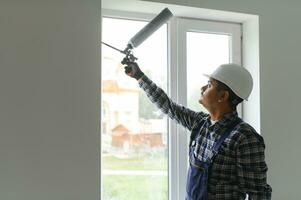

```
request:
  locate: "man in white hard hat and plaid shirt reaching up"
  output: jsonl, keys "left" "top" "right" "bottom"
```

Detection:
{"left": 122, "top": 59, "right": 272, "bottom": 200}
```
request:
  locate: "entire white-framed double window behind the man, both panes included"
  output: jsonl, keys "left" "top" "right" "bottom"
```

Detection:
{"left": 101, "top": 11, "right": 241, "bottom": 200}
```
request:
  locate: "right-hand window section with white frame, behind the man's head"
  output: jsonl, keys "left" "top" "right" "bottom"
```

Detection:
{"left": 170, "top": 18, "right": 241, "bottom": 199}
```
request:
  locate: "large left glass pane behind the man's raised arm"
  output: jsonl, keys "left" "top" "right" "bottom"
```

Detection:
{"left": 101, "top": 18, "right": 168, "bottom": 200}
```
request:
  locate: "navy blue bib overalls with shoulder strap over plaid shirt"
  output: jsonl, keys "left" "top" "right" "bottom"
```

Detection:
{"left": 186, "top": 119, "right": 240, "bottom": 200}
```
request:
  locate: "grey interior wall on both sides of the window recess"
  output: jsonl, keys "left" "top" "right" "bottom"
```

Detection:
{"left": 0, "top": 0, "right": 301, "bottom": 200}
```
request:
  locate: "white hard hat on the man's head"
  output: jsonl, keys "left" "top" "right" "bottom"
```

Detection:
{"left": 204, "top": 63, "right": 253, "bottom": 100}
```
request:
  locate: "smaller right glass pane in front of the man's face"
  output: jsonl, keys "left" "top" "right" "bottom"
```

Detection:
{"left": 186, "top": 32, "right": 230, "bottom": 112}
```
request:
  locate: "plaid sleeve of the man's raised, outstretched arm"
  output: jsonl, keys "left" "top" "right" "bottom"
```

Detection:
{"left": 138, "top": 75, "right": 205, "bottom": 130}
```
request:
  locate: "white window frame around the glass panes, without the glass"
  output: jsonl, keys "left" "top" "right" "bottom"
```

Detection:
{"left": 102, "top": 9, "right": 242, "bottom": 200}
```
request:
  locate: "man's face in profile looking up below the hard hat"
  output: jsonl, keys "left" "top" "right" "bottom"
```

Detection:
{"left": 199, "top": 78, "right": 219, "bottom": 109}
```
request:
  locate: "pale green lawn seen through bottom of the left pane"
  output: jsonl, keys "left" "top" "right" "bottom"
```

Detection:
{"left": 102, "top": 154, "right": 168, "bottom": 200}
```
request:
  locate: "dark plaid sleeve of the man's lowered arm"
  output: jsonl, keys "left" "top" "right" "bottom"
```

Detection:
{"left": 237, "top": 133, "right": 272, "bottom": 200}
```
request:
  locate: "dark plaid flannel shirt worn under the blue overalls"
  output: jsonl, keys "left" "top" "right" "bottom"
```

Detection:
{"left": 139, "top": 76, "right": 272, "bottom": 200}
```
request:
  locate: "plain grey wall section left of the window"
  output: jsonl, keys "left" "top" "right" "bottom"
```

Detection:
{"left": 0, "top": 0, "right": 101, "bottom": 200}
